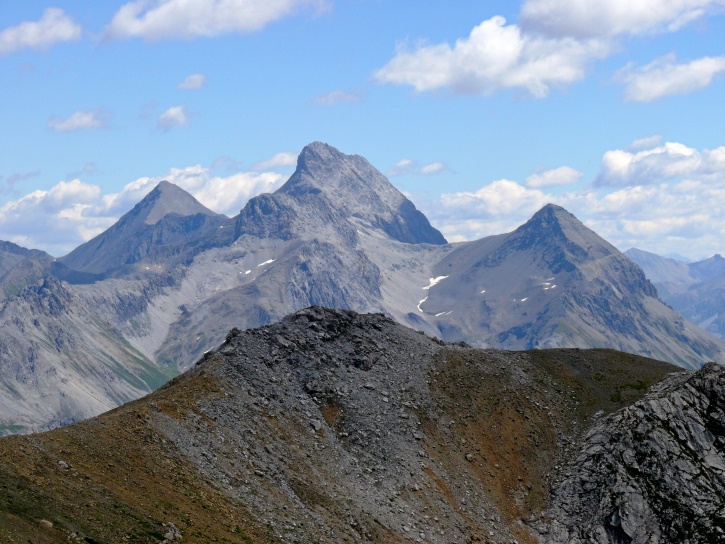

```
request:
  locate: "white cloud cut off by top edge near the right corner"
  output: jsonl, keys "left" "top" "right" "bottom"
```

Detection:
{"left": 521, "top": 0, "right": 725, "bottom": 38}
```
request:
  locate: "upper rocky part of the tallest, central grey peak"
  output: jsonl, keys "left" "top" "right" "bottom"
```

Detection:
{"left": 235, "top": 142, "right": 446, "bottom": 244}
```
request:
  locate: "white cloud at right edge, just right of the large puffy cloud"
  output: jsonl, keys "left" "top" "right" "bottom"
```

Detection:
{"left": 615, "top": 55, "right": 725, "bottom": 102}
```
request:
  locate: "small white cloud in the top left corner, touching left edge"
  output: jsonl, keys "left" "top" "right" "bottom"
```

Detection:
{"left": 0, "top": 8, "right": 82, "bottom": 55}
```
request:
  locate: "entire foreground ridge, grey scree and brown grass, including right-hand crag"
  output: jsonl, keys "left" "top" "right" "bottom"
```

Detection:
{"left": 0, "top": 307, "right": 725, "bottom": 544}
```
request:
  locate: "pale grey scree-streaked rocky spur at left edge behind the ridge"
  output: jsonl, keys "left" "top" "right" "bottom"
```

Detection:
{"left": 0, "top": 276, "right": 173, "bottom": 434}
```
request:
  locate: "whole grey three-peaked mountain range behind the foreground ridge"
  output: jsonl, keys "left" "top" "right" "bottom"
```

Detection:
{"left": 0, "top": 142, "right": 725, "bottom": 432}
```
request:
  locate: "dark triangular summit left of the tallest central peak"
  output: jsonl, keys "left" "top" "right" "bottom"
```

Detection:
{"left": 58, "top": 181, "right": 229, "bottom": 277}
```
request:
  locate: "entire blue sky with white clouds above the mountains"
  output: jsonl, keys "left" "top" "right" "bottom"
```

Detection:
{"left": 0, "top": 0, "right": 725, "bottom": 258}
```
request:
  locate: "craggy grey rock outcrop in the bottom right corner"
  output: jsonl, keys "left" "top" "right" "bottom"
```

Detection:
{"left": 542, "top": 363, "right": 725, "bottom": 544}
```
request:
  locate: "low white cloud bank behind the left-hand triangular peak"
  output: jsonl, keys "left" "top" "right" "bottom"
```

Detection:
{"left": 0, "top": 165, "right": 286, "bottom": 256}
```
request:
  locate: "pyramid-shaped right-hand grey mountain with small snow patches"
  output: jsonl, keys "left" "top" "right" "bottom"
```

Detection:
{"left": 421, "top": 205, "right": 723, "bottom": 368}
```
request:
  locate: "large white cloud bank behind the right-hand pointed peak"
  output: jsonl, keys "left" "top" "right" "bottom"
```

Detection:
{"left": 421, "top": 139, "right": 725, "bottom": 259}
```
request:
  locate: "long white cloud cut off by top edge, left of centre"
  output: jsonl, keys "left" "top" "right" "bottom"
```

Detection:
{"left": 107, "top": 0, "right": 327, "bottom": 40}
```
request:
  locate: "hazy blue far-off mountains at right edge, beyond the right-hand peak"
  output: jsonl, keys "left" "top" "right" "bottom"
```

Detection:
{"left": 625, "top": 248, "right": 725, "bottom": 339}
